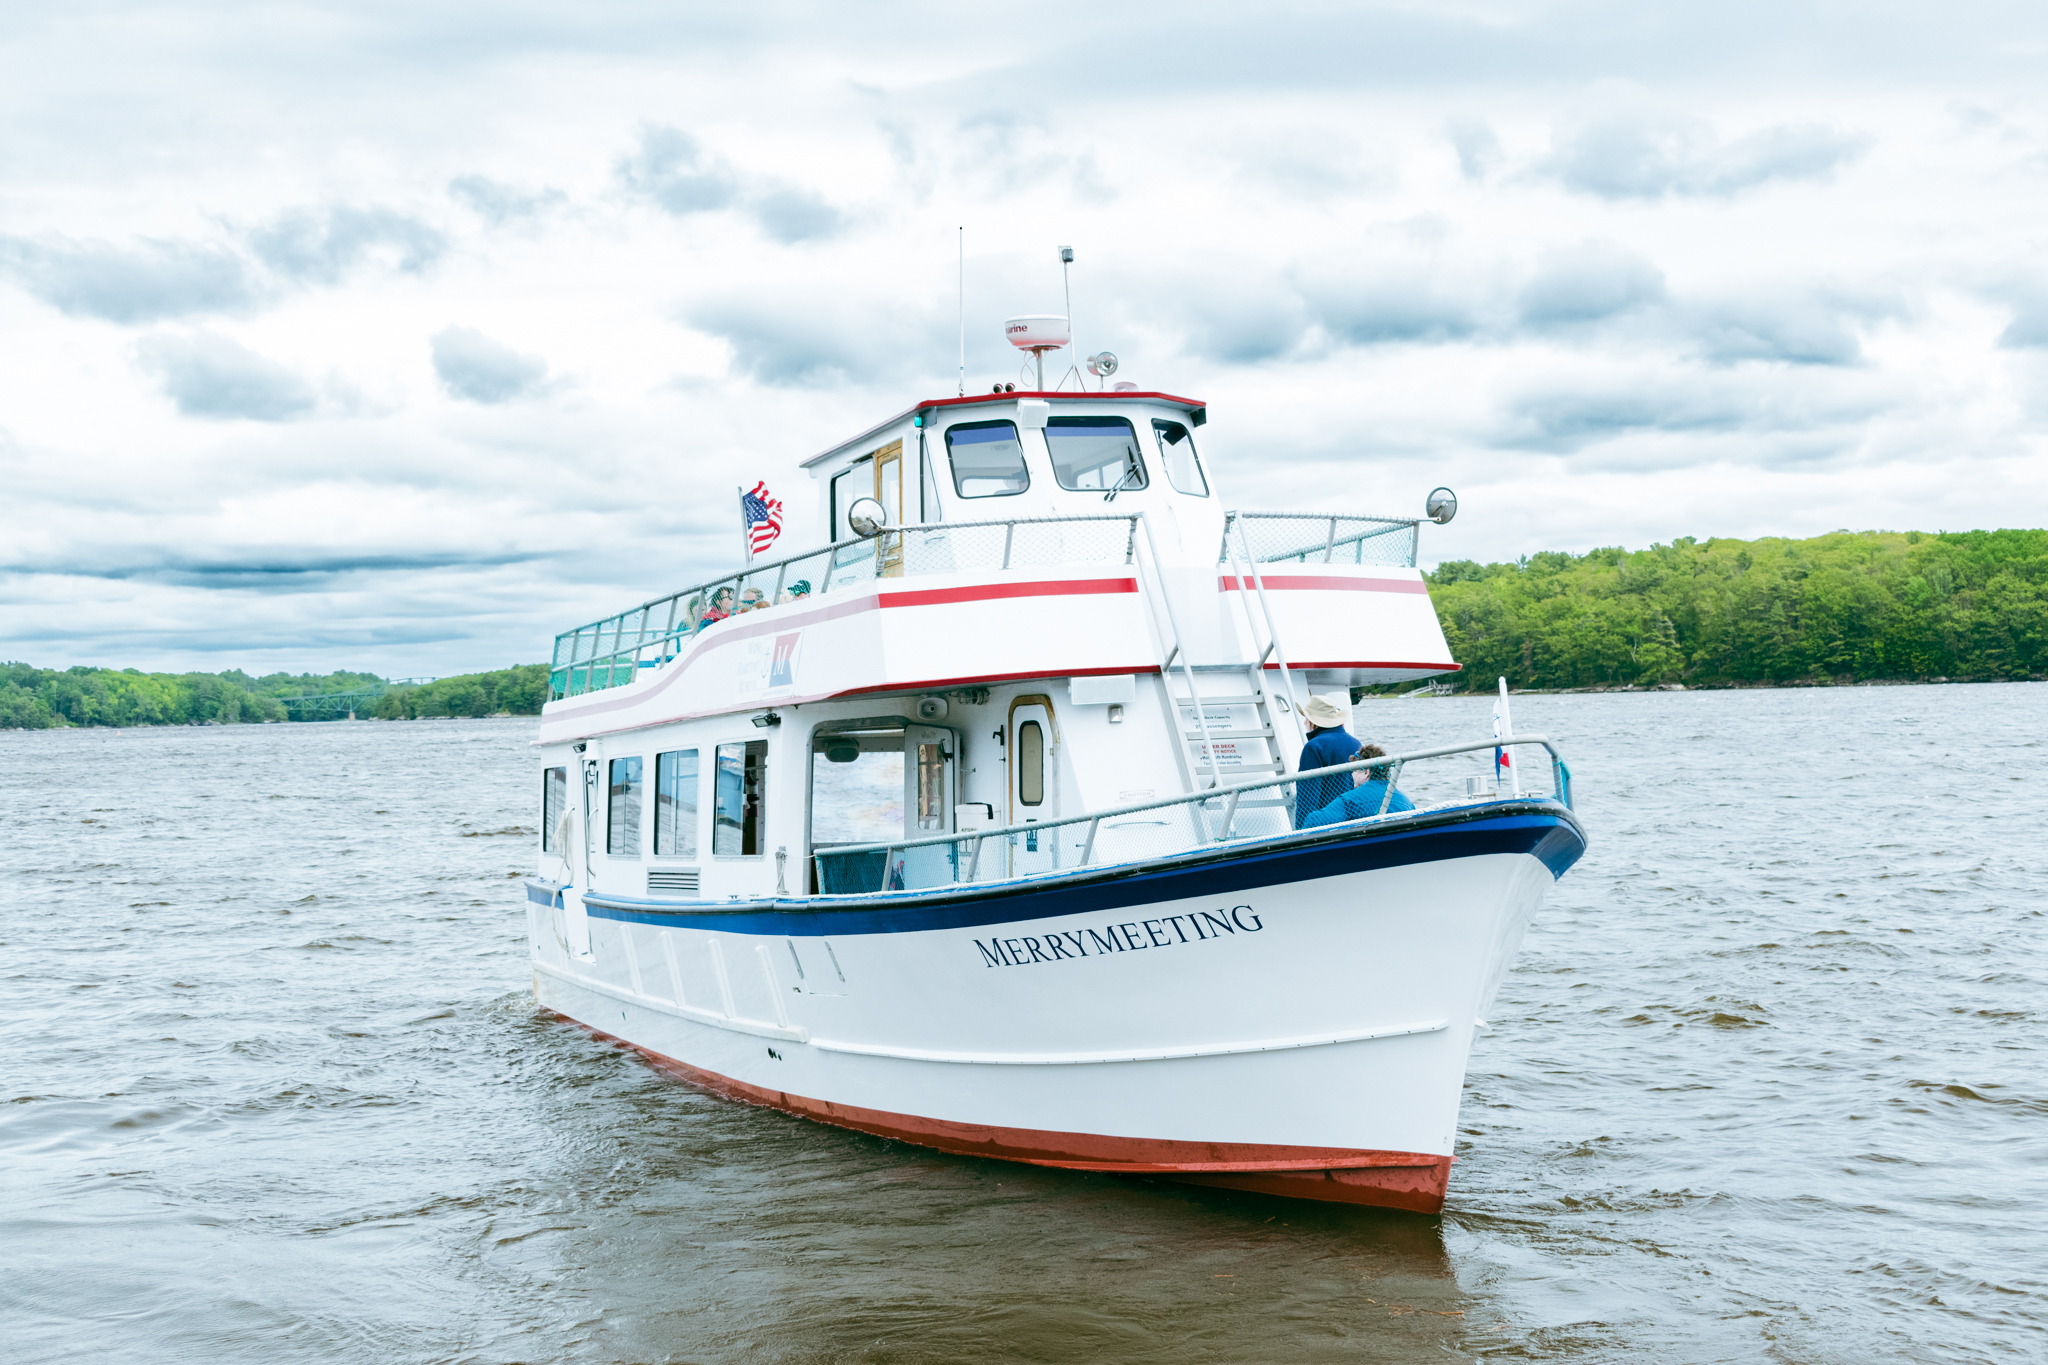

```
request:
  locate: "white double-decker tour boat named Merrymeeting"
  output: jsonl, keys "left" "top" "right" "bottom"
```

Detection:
{"left": 528, "top": 319, "right": 1585, "bottom": 1212}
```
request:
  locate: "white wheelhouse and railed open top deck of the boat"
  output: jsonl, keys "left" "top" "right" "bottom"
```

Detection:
{"left": 551, "top": 391, "right": 1419, "bottom": 698}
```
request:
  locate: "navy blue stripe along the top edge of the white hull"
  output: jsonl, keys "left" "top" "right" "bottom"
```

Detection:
{"left": 526, "top": 802, "right": 1585, "bottom": 937}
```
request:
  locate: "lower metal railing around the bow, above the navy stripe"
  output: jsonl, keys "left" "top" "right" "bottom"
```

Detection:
{"left": 811, "top": 735, "right": 1571, "bottom": 894}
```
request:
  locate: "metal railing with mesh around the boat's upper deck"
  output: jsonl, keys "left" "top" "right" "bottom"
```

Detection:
{"left": 549, "top": 512, "right": 1417, "bottom": 700}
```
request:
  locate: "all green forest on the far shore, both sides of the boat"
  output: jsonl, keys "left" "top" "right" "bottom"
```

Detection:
{"left": 0, "top": 530, "right": 2048, "bottom": 729}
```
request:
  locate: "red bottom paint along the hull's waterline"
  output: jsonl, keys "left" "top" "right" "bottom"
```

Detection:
{"left": 561, "top": 1015, "right": 1454, "bottom": 1214}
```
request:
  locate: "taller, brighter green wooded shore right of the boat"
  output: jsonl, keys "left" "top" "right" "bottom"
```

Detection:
{"left": 1427, "top": 530, "right": 2048, "bottom": 690}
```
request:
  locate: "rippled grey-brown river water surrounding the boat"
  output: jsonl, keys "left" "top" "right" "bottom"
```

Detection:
{"left": 0, "top": 684, "right": 2048, "bottom": 1363}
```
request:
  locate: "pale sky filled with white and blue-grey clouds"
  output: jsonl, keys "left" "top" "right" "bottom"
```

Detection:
{"left": 0, "top": 0, "right": 2048, "bottom": 675}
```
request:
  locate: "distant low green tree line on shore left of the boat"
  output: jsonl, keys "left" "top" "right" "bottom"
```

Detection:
{"left": 0, "top": 663, "right": 547, "bottom": 731}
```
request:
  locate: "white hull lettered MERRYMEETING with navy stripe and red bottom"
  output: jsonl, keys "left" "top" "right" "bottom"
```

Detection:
{"left": 528, "top": 802, "right": 1585, "bottom": 1212}
